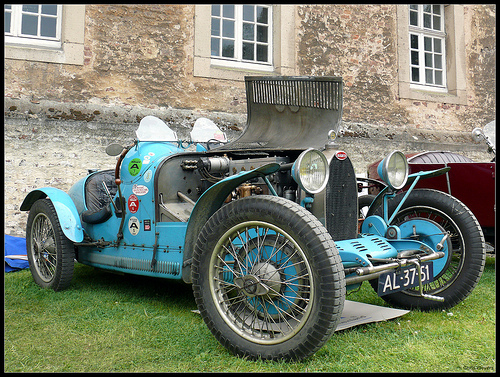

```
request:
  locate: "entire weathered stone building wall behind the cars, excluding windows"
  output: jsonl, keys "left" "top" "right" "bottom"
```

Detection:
{"left": 4, "top": 4, "right": 496, "bottom": 235}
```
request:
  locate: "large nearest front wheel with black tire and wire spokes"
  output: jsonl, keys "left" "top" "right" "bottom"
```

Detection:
{"left": 192, "top": 195, "right": 345, "bottom": 360}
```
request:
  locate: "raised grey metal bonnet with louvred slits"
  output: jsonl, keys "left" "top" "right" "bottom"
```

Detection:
{"left": 217, "top": 76, "right": 342, "bottom": 150}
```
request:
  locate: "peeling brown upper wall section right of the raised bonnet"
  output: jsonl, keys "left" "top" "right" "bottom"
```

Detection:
{"left": 297, "top": 4, "right": 496, "bottom": 133}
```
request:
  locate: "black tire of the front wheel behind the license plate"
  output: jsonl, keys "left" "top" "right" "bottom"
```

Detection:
{"left": 370, "top": 189, "right": 486, "bottom": 311}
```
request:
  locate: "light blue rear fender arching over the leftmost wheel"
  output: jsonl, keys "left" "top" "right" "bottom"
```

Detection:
{"left": 20, "top": 187, "right": 83, "bottom": 242}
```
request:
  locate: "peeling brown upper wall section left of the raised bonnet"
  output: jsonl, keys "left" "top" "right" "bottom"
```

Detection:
{"left": 4, "top": 4, "right": 250, "bottom": 116}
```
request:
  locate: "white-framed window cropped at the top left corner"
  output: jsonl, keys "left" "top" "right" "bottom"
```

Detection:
{"left": 4, "top": 4, "right": 62, "bottom": 48}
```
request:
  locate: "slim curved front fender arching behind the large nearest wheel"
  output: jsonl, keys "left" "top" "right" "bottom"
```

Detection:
{"left": 182, "top": 163, "right": 280, "bottom": 283}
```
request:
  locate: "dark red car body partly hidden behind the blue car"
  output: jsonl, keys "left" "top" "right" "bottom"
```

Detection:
{"left": 367, "top": 151, "right": 495, "bottom": 242}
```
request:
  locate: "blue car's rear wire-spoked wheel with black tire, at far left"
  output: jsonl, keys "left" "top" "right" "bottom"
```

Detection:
{"left": 26, "top": 199, "right": 75, "bottom": 291}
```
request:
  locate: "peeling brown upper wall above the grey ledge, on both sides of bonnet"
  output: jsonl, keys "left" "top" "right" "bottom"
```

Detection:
{"left": 4, "top": 4, "right": 496, "bottom": 124}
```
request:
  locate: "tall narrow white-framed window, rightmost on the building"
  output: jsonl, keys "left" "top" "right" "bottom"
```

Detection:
{"left": 408, "top": 4, "right": 446, "bottom": 90}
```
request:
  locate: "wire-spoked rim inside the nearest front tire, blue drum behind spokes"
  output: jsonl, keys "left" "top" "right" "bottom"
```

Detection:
{"left": 209, "top": 221, "right": 314, "bottom": 344}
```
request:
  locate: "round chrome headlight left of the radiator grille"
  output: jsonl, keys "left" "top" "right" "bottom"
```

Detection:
{"left": 292, "top": 148, "right": 330, "bottom": 194}
